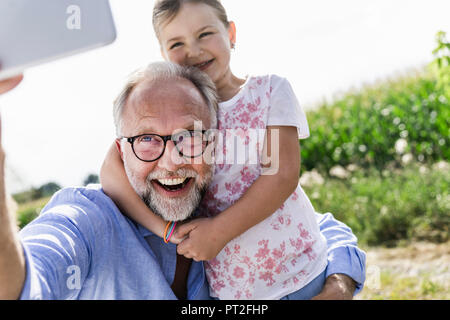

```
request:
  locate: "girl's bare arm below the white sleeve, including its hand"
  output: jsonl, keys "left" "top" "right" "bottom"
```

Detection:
{"left": 175, "top": 126, "right": 300, "bottom": 261}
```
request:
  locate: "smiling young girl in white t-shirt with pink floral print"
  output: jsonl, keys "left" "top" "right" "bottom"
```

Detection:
{"left": 101, "top": 0, "right": 327, "bottom": 299}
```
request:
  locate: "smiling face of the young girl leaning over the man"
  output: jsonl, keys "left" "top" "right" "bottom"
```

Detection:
{"left": 159, "top": 3, "right": 236, "bottom": 85}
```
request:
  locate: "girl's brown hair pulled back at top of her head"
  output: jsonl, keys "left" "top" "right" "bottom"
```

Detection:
{"left": 153, "top": 0, "right": 230, "bottom": 38}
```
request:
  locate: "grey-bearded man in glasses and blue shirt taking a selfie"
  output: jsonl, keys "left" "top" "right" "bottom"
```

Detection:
{"left": 0, "top": 63, "right": 365, "bottom": 299}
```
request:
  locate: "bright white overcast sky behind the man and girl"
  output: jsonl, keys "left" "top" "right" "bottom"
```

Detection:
{"left": 0, "top": 0, "right": 450, "bottom": 192}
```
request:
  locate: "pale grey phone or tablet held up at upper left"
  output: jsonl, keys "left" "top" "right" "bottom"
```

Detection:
{"left": 0, "top": 0, "right": 116, "bottom": 80}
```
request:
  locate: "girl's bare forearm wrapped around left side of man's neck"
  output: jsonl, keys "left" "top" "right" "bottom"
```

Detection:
{"left": 100, "top": 144, "right": 179, "bottom": 243}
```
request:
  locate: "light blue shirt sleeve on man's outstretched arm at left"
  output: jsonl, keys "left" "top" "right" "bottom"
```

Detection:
{"left": 19, "top": 190, "right": 99, "bottom": 300}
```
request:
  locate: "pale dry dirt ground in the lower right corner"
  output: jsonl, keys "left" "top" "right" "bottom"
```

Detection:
{"left": 355, "top": 242, "right": 450, "bottom": 300}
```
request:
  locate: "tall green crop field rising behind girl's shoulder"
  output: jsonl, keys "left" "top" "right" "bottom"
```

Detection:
{"left": 301, "top": 66, "right": 450, "bottom": 172}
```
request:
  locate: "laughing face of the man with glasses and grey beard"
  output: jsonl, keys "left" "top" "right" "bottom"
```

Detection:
{"left": 118, "top": 79, "right": 213, "bottom": 221}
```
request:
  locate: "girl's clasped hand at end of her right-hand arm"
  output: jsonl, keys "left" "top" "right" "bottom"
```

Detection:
{"left": 174, "top": 218, "right": 228, "bottom": 261}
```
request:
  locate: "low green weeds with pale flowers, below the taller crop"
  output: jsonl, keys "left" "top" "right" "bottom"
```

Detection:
{"left": 304, "top": 164, "right": 450, "bottom": 246}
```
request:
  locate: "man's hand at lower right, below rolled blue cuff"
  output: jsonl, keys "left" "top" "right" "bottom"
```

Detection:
{"left": 312, "top": 274, "right": 356, "bottom": 300}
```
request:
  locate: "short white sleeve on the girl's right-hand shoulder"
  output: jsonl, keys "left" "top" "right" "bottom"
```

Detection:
{"left": 267, "top": 76, "right": 309, "bottom": 139}
